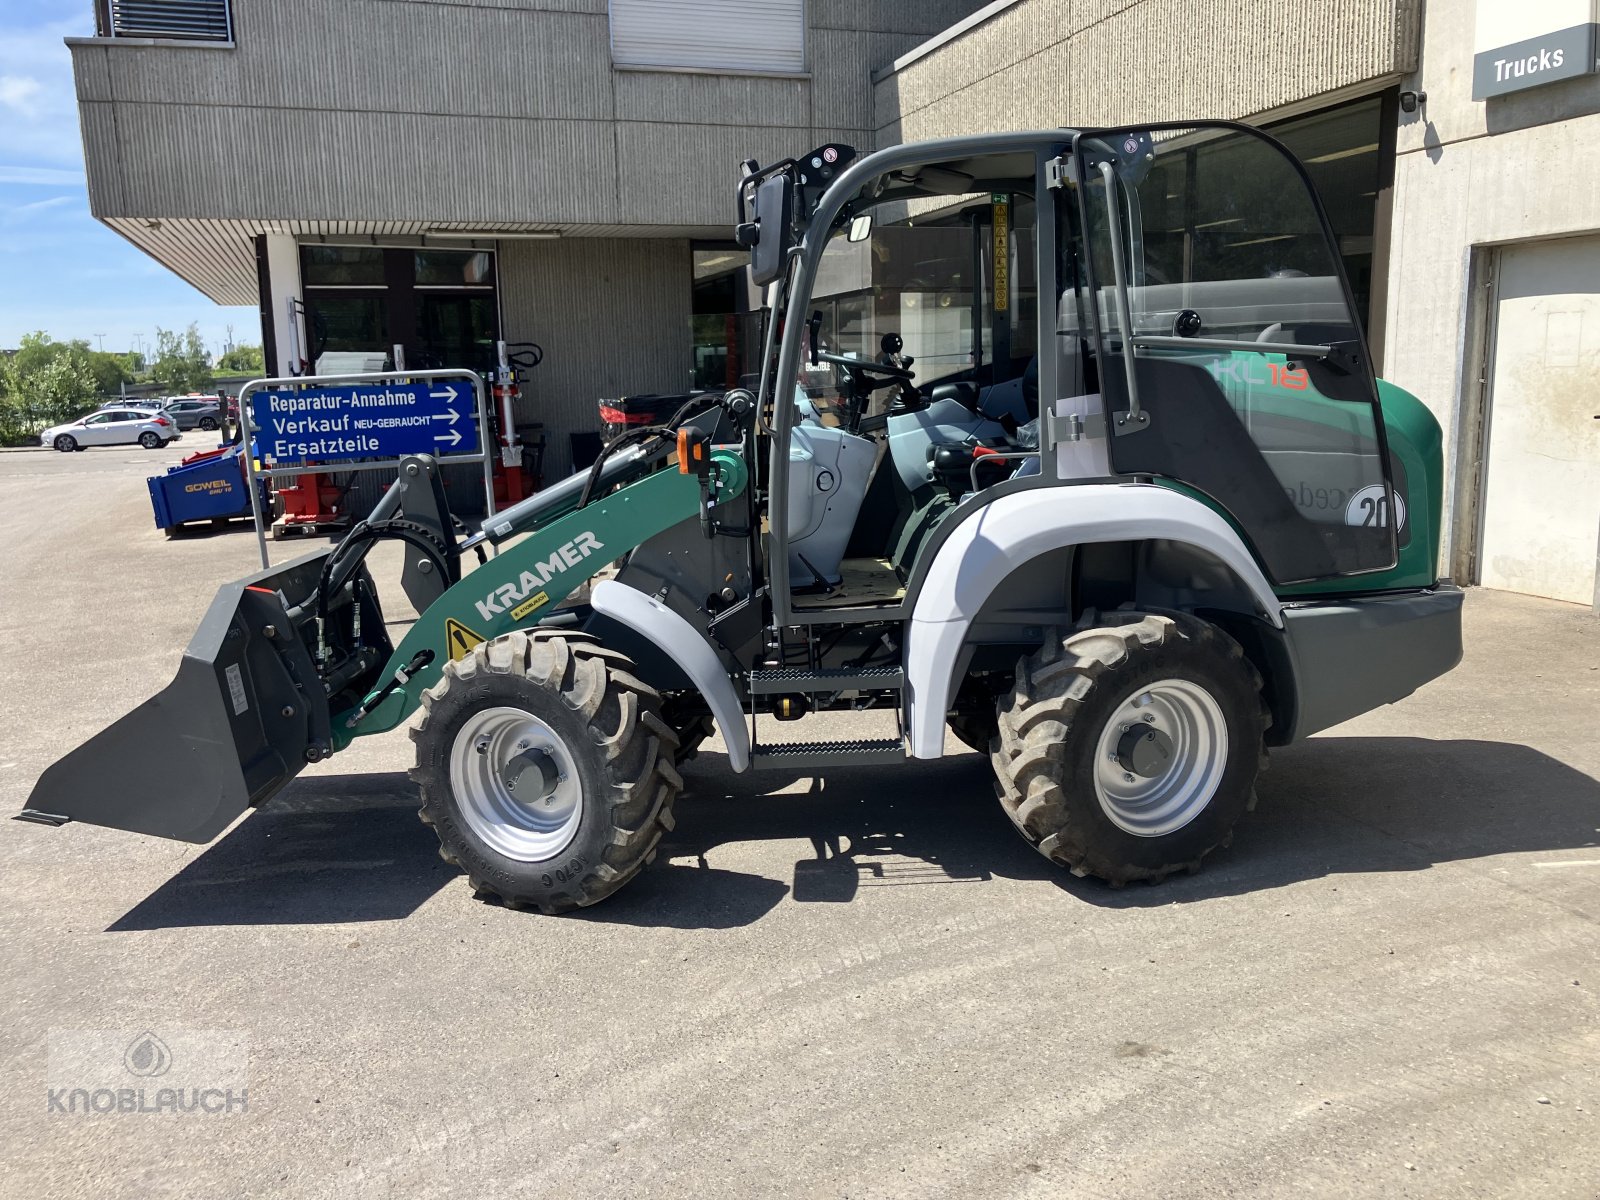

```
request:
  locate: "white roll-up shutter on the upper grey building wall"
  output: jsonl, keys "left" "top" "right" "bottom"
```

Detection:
{"left": 611, "top": 0, "right": 805, "bottom": 74}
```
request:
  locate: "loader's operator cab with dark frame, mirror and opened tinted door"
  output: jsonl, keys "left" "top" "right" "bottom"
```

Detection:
{"left": 741, "top": 123, "right": 1406, "bottom": 619}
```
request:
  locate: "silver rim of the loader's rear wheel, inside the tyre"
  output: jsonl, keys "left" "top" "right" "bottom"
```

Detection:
{"left": 1094, "top": 678, "right": 1227, "bottom": 837}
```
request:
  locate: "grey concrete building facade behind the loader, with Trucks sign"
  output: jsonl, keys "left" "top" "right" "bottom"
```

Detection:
{"left": 72, "top": 0, "right": 1600, "bottom": 603}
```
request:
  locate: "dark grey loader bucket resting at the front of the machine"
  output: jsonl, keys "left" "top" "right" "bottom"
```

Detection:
{"left": 19, "top": 550, "right": 363, "bottom": 843}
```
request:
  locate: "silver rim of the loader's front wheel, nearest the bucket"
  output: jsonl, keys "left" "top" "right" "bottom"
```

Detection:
{"left": 450, "top": 707, "right": 584, "bottom": 862}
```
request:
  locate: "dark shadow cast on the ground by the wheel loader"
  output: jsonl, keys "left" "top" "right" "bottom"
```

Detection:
{"left": 109, "top": 738, "right": 1600, "bottom": 931}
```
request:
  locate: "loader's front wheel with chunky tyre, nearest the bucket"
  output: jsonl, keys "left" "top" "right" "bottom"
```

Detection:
{"left": 411, "top": 632, "right": 682, "bottom": 914}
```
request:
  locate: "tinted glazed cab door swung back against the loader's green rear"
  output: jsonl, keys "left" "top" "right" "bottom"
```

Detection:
{"left": 1058, "top": 126, "right": 1406, "bottom": 584}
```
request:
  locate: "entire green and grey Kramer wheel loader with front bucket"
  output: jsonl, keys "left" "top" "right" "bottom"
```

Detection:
{"left": 22, "top": 122, "right": 1462, "bottom": 914}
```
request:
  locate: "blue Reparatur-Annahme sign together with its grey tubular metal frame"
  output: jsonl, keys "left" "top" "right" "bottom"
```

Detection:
{"left": 238, "top": 370, "right": 494, "bottom": 566}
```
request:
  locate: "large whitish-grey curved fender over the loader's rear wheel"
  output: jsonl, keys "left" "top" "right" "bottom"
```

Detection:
{"left": 902, "top": 483, "right": 1283, "bottom": 758}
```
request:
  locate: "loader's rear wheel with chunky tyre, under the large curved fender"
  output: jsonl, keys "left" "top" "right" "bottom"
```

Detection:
{"left": 990, "top": 613, "right": 1269, "bottom": 886}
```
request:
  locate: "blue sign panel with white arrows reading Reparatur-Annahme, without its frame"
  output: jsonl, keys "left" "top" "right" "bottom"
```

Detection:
{"left": 250, "top": 379, "right": 478, "bottom": 464}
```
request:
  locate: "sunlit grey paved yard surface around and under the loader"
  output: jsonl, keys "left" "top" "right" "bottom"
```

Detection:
{"left": 0, "top": 438, "right": 1600, "bottom": 1198}
